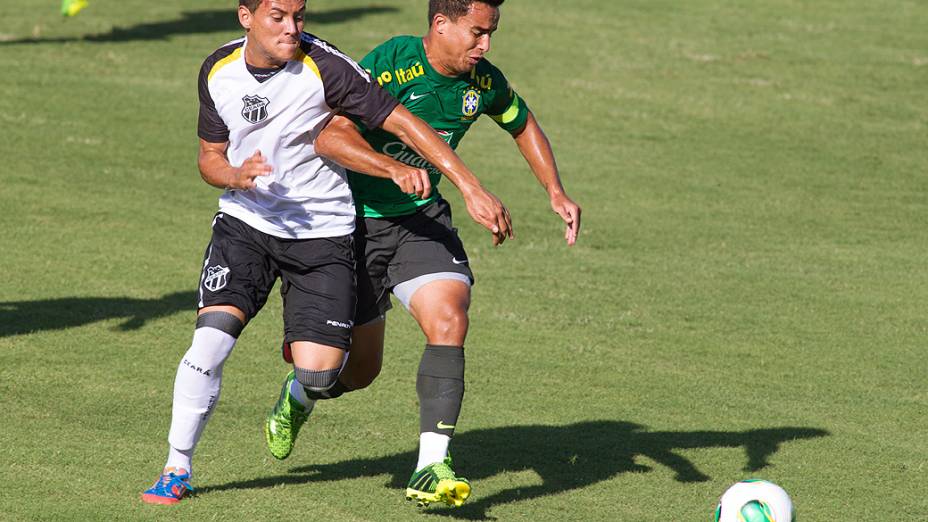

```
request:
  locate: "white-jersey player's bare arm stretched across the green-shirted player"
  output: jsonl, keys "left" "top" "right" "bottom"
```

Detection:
{"left": 383, "top": 105, "right": 513, "bottom": 245}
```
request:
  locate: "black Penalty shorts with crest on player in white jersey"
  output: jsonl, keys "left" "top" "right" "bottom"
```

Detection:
{"left": 198, "top": 213, "right": 357, "bottom": 348}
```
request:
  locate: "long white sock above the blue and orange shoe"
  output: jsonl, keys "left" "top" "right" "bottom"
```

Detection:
{"left": 166, "top": 327, "right": 236, "bottom": 471}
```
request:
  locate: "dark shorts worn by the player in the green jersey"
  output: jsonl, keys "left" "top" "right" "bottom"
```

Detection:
{"left": 355, "top": 199, "right": 474, "bottom": 324}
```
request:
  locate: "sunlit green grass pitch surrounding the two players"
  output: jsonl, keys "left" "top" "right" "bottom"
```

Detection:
{"left": 0, "top": 0, "right": 928, "bottom": 522}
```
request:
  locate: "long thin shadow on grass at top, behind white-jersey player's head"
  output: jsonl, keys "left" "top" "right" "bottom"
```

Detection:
{"left": 0, "top": 6, "right": 398, "bottom": 45}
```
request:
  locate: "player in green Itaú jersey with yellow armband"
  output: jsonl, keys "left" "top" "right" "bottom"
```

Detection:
{"left": 265, "top": 0, "right": 580, "bottom": 506}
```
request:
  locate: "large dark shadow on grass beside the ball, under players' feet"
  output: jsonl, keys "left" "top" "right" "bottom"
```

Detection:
{"left": 199, "top": 421, "right": 828, "bottom": 520}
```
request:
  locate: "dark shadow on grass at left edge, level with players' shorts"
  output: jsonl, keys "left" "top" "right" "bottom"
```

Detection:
{"left": 0, "top": 292, "right": 196, "bottom": 337}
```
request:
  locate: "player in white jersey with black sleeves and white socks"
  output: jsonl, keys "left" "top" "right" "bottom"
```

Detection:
{"left": 142, "top": 0, "right": 511, "bottom": 504}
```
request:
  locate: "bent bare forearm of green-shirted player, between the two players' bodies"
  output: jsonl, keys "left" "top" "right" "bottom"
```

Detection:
{"left": 315, "top": 116, "right": 432, "bottom": 199}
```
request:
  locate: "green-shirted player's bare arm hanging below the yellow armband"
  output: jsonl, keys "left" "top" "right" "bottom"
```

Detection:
{"left": 513, "top": 112, "right": 580, "bottom": 245}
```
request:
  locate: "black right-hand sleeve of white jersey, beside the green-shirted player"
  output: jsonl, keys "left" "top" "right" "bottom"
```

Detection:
{"left": 307, "top": 39, "right": 399, "bottom": 129}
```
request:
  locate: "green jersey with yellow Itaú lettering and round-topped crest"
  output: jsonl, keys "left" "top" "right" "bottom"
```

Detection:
{"left": 348, "top": 36, "right": 528, "bottom": 217}
